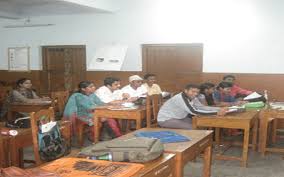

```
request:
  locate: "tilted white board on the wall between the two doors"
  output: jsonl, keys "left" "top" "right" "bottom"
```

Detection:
{"left": 87, "top": 45, "right": 127, "bottom": 71}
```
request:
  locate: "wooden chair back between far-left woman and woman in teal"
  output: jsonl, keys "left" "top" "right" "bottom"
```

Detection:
{"left": 50, "top": 91, "right": 69, "bottom": 117}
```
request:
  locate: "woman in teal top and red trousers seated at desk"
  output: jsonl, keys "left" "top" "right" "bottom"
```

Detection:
{"left": 63, "top": 81, "right": 121, "bottom": 137}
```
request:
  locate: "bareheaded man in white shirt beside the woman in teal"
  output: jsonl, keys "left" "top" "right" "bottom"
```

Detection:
{"left": 95, "top": 77, "right": 129, "bottom": 104}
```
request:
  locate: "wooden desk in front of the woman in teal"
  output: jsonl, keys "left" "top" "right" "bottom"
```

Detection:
{"left": 94, "top": 106, "right": 146, "bottom": 143}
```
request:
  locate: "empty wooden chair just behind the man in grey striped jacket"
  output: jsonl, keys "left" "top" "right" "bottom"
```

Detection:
{"left": 146, "top": 94, "right": 163, "bottom": 128}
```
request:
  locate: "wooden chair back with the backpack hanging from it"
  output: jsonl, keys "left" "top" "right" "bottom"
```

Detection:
{"left": 30, "top": 107, "right": 54, "bottom": 165}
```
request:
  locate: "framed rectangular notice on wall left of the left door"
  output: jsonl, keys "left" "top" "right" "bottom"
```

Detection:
{"left": 8, "top": 47, "right": 30, "bottom": 71}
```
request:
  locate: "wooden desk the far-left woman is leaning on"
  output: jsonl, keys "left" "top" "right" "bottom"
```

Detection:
{"left": 7, "top": 103, "right": 51, "bottom": 120}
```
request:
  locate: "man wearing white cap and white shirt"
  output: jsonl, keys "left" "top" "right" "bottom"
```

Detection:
{"left": 121, "top": 75, "right": 147, "bottom": 99}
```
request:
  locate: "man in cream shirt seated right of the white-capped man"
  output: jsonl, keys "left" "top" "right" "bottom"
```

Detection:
{"left": 143, "top": 74, "right": 162, "bottom": 95}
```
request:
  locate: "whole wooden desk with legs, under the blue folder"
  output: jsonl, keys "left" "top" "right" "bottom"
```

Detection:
{"left": 116, "top": 128, "right": 212, "bottom": 177}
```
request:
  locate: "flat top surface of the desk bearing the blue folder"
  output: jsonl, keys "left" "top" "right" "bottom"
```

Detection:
{"left": 116, "top": 128, "right": 213, "bottom": 152}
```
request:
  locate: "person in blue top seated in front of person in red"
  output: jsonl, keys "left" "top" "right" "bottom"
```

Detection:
{"left": 213, "top": 82, "right": 246, "bottom": 106}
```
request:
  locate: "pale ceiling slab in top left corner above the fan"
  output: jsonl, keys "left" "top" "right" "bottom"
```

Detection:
{"left": 0, "top": 0, "right": 115, "bottom": 19}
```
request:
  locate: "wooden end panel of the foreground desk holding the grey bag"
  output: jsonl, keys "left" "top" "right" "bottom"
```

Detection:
{"left": 141, "top": 158, "right": 175, "bottom": 177}
